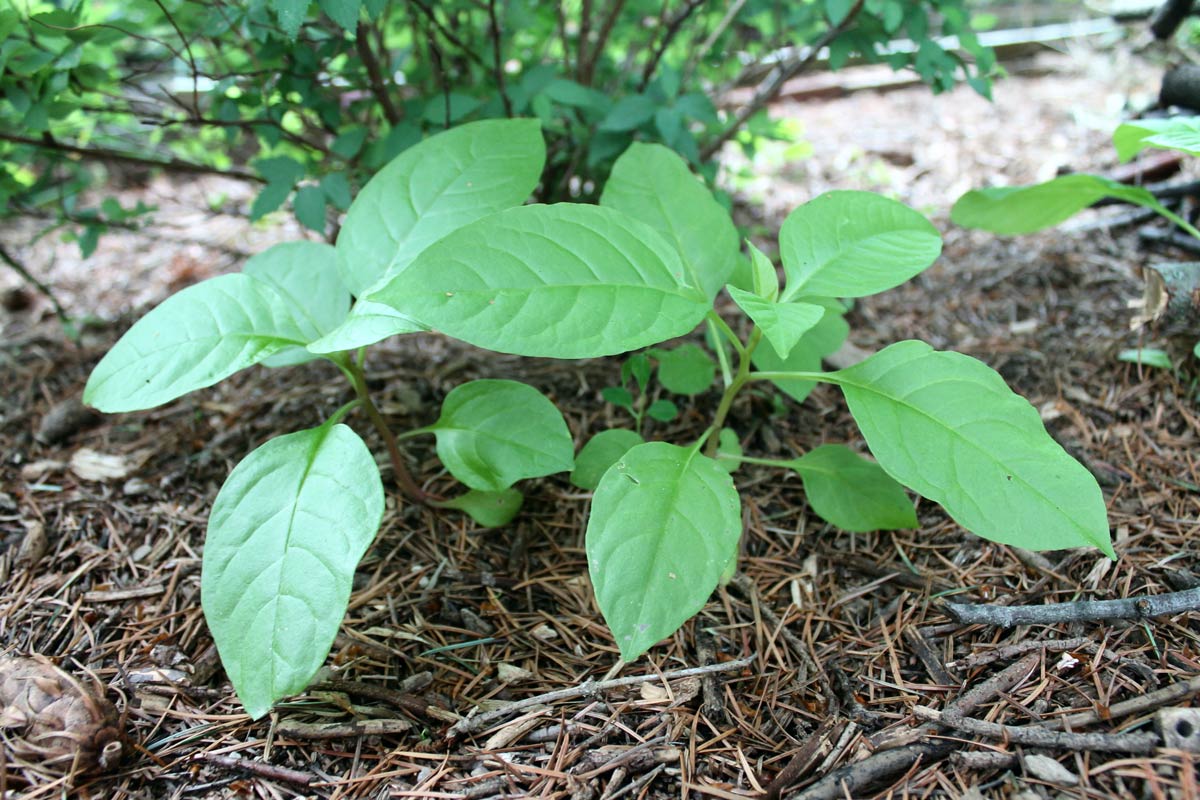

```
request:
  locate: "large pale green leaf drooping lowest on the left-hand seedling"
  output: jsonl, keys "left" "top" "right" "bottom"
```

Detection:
{"left": 200, "top": 423, "right": 383, "bottom": 720}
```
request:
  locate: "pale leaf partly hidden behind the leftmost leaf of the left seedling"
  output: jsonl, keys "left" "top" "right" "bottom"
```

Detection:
{"left": 241, "top": 241, "right": 350, "bottom": 367}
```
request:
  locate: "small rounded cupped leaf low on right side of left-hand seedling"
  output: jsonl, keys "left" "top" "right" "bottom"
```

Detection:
{"left": 428, "top": 380, "right": 575, "bottom": 492}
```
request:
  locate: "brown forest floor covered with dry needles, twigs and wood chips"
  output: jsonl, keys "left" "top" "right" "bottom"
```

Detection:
{"left": 0, "top": 28, "right": 1200, "bottom": 800}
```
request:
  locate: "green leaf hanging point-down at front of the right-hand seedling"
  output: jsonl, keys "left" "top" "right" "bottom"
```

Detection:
{"left": 586, "top": 441, "right": 742, "bottom": 661}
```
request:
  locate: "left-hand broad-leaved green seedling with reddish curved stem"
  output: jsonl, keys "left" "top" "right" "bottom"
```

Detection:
{"left": 84, "top": 120, "right": 574, "bottom": 718}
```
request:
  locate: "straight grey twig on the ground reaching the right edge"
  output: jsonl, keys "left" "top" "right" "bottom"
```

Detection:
{"left": 943, "top": 588, "right": 1200, "bottom": 627}
